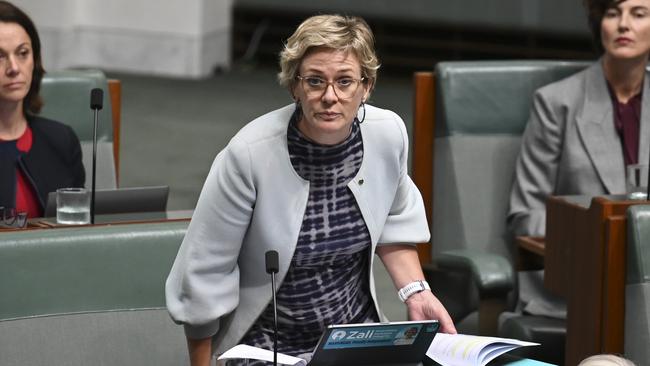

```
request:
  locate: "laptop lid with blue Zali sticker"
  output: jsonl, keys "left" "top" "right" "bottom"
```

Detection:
{"left": 309, "top": 320, "right": 440, "bottom": 366}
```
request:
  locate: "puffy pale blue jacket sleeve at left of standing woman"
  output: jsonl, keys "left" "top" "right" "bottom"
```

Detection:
{"left": 165, "top": 142, "right": 255, "bottom": 339}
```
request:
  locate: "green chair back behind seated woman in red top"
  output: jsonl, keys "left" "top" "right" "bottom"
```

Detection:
{"left": 40, "top": 70, "right": 117, "bottom": 189}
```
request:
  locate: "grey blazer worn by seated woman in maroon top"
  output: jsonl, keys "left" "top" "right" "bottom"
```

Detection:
{"left": 507, "top": 61, "right": 650, "bottom": 236}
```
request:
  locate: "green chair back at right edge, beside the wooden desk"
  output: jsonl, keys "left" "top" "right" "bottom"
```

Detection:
{"left": 625, "top": 205, "right": 650, "bottom": 365}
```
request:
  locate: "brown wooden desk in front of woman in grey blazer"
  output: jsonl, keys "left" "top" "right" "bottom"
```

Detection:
{"left": 544, "top": 197, "right": 647, "bottom": 365}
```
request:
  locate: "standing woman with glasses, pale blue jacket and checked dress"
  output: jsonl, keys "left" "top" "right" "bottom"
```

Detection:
{"left": 166, "top": 15, "right": 455, "bottom": 366}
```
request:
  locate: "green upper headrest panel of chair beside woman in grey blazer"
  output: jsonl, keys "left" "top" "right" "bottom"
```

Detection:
{"left": 436, "top": 61, "right": 590, "bottom": 137}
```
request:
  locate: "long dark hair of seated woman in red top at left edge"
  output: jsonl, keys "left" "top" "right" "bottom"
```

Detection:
{"left": 0, "top": 0, "right": 45, "bottom": 114}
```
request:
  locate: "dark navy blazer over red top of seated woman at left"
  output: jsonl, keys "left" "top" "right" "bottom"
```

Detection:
{"left": 0, "top": 116, "right": 86, "bottom": 210}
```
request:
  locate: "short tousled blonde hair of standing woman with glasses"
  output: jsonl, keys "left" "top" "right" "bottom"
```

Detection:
{"left": 278, "top": 15, "right": 379, "bottom": 91}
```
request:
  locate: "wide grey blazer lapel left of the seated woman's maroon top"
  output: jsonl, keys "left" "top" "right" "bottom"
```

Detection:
{"left": 576, "top": 60, "right": 624, "bottom": 194}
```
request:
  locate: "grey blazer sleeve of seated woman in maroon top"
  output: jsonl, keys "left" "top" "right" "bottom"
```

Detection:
{"left": 507, "top": 91, "right": 565, "bottom": 236}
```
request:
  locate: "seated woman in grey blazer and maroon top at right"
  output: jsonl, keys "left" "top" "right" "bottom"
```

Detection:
{"left": 507, "top": 0, "right": 650, "bottom": 236}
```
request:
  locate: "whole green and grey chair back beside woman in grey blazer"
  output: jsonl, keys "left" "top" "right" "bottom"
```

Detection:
{"left": 432, "top": 61, "right": 589, "bottom": 257}
